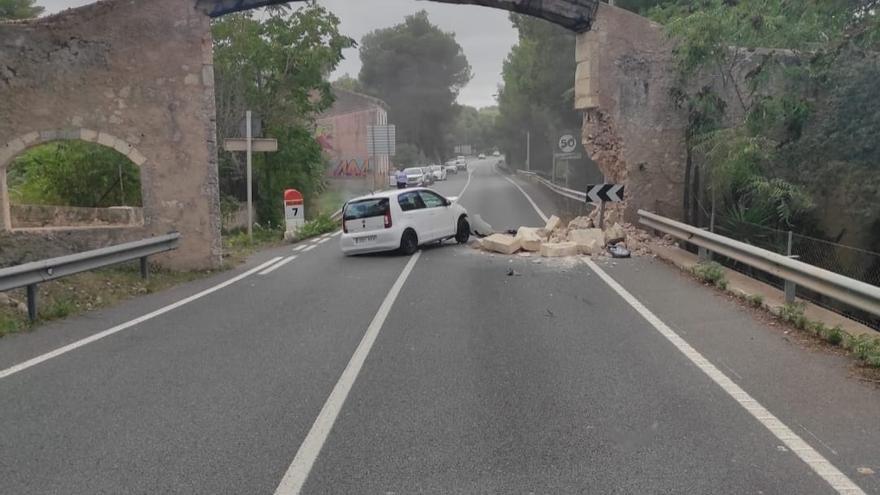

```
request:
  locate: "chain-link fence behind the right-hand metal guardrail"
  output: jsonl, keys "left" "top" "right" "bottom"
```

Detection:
{"left": 688, "top": 212, "right": 880, "bottom": 329}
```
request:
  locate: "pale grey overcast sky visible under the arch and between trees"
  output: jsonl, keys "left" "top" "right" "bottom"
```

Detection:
{"left": 36, "top": 0, "right": 517, "bottom": 107}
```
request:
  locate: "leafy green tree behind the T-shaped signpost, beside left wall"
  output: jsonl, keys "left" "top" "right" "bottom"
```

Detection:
{"left": 212, "top": 3, "right": 354, "bottom": 225}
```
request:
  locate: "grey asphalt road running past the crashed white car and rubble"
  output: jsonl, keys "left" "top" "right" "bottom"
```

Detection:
{"left": 0, "top": 159, "right": 880, "bottom": 494}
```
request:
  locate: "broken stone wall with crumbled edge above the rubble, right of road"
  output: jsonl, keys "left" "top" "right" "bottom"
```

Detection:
{"left": 575, "top": 4, "right": 687, "bottom": 222}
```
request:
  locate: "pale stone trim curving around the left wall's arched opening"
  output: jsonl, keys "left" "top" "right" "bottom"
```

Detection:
{"left": 0, "top": 128, "right": 149, "bottom": 231}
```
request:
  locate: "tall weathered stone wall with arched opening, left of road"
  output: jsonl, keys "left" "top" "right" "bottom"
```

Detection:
{"left": 0, "top": 0, "right": 221, "bottom": 269}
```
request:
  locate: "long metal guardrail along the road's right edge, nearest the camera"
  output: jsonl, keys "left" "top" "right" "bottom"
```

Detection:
{"left": 639, "top": 210, "right": 880, "bottom": 316}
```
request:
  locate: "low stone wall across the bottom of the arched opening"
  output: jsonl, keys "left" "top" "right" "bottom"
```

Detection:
{"left": 9, "top": 205, "right": 144, "bottom": 229}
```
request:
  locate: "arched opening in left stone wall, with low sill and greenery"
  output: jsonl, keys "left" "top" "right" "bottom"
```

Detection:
{"left": 0, "top": 131, "right": 144, "bottom": 232}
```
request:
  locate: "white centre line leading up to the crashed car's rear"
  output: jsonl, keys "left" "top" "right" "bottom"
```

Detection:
{"left": 275, "top": 251, "right": 422, "bottom": 495}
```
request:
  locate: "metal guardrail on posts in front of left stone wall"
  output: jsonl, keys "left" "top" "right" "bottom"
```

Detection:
{"left": 0, "top": 232, "right": 180, "bottom": 321}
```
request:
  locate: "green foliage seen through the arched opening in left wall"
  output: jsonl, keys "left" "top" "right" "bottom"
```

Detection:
{"left": 8, "top": 141, "right": 141, "bottom": 207}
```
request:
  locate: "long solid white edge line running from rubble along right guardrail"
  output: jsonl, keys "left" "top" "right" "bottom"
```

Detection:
{"left": 585, "top": 259, "right": 865, "bottom": 494}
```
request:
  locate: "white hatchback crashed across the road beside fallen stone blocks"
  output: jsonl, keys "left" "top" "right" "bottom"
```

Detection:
{"left": 339, "top": 188, "right": 471, "bottom": 256}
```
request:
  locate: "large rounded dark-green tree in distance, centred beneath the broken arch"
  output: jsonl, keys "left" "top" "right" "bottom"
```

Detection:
{"left": 358, "top": 11, "right": 471, "bottom": 159}
